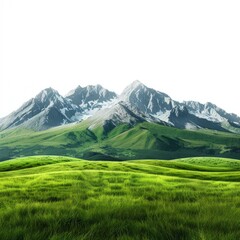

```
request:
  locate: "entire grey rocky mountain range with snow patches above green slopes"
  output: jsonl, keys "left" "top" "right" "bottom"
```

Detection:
{"left": 0, "top": 80, "right": 240, "bottom": 133}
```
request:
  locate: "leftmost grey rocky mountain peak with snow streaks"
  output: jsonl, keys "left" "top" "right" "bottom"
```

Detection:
{"left": 0, "top": 88, "right": 82, "bottom": 130}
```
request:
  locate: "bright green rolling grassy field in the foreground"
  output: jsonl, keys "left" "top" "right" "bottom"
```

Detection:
{"left": 0, "top": 156, "right": 240, "bottom": 240}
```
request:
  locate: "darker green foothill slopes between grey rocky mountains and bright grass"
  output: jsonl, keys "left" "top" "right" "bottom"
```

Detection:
{"left": 0, "top": 121, "right": 240, "bottom": 160}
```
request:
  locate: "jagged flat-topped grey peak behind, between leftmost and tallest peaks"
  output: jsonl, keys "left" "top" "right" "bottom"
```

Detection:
{"left": 66, "top": 85, "right": 117, "bottom": 115}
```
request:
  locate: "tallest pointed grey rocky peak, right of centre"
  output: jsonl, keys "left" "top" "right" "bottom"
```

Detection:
{"left": 119, "top": 80, "right": 177, "bottom": 115}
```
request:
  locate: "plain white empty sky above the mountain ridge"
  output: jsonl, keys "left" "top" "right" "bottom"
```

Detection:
{"left": 0, "top": 0, "right": 240, "bottom": 117}
